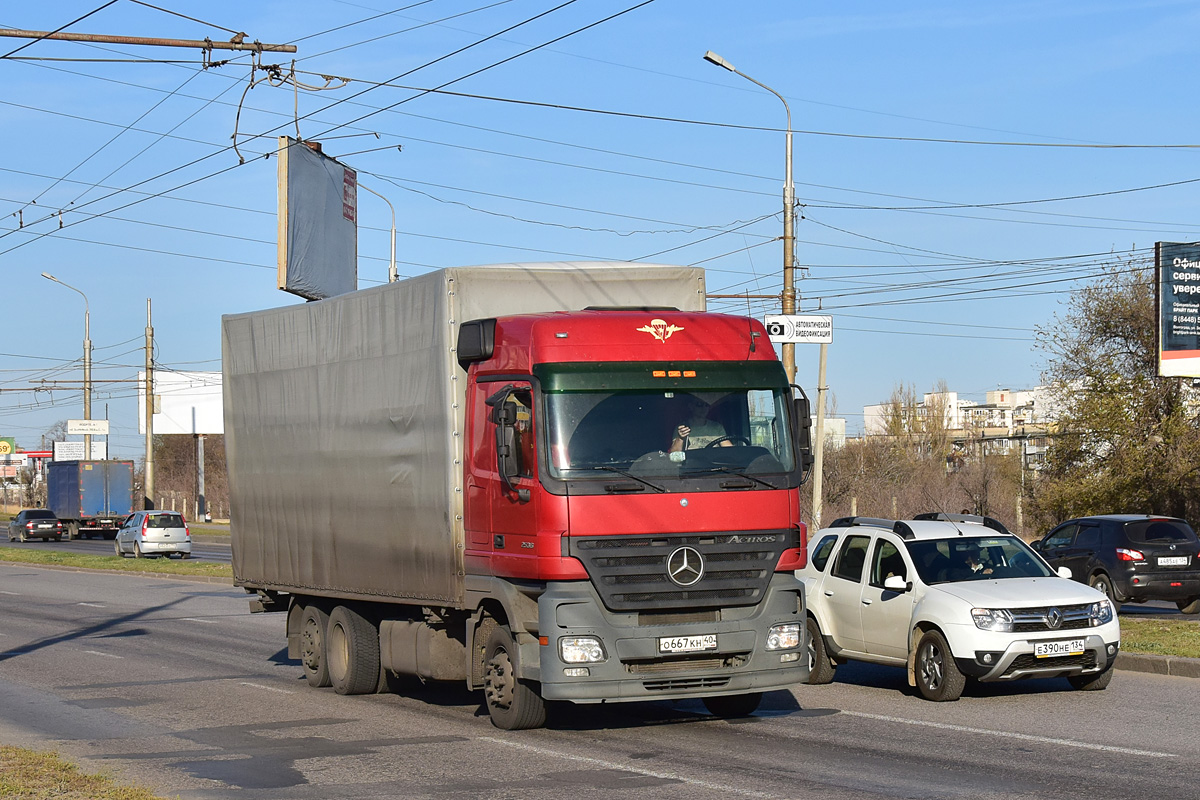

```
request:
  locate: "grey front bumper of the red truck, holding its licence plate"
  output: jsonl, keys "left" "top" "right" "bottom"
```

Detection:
{"left": 538, "top": 573, "right": 809, "bottom": 703}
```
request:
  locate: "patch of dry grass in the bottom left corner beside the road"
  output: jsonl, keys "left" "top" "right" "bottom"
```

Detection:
{"left": 0, "top": 745, "right": 169, "bottom": 800}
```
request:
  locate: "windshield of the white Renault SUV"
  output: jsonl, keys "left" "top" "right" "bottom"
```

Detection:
{"left": 905, "top": 536, "right": 1054, "bottom": 585}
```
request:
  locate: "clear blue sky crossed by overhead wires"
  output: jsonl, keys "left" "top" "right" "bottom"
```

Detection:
{"left": 0, "top": 0, "right": 1200, "bottom": 457}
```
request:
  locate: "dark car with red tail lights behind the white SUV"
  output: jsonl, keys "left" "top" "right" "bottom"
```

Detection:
{"left": 1033, "top": 513, "right": 1200, "bottom": 614}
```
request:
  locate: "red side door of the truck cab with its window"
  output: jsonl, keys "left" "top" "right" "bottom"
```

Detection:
{"left": 467, "top": 380, "right": 538, "bottom": 563}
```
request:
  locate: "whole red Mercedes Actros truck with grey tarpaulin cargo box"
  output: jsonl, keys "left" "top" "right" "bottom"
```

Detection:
{"left": 222, "top": 263, "right": 811, "bottom": 729}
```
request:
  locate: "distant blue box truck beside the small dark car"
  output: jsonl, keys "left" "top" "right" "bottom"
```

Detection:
{"left": 46, "top": 461, "right": 133, "bottom": 539}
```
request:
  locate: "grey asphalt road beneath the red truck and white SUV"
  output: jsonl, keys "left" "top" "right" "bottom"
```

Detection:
{"left": 0, "top": 565, "right": 1200, "bottom": 800}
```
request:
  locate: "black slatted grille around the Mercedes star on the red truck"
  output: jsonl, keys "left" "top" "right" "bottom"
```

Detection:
{"left": 568, "top": 530, "right": 798, "bottom": 610}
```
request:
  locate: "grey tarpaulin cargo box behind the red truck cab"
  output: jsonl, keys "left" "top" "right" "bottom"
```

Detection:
{"left": 222, "top": 261, "right": 704, "bottom": 606}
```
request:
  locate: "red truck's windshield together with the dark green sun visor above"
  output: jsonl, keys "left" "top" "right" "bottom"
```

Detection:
{"left": 541, "top": 362, "right": 794, "bottom": 480}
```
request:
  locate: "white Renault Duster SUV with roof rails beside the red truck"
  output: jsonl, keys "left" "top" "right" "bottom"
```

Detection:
{"left": 796, "top": 513, "right": 1121, "bottom": 700}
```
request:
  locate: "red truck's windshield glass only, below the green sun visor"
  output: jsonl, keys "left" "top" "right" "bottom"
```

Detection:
{"left": 545, "top": 386, "right": 793, "bottom": 480}
